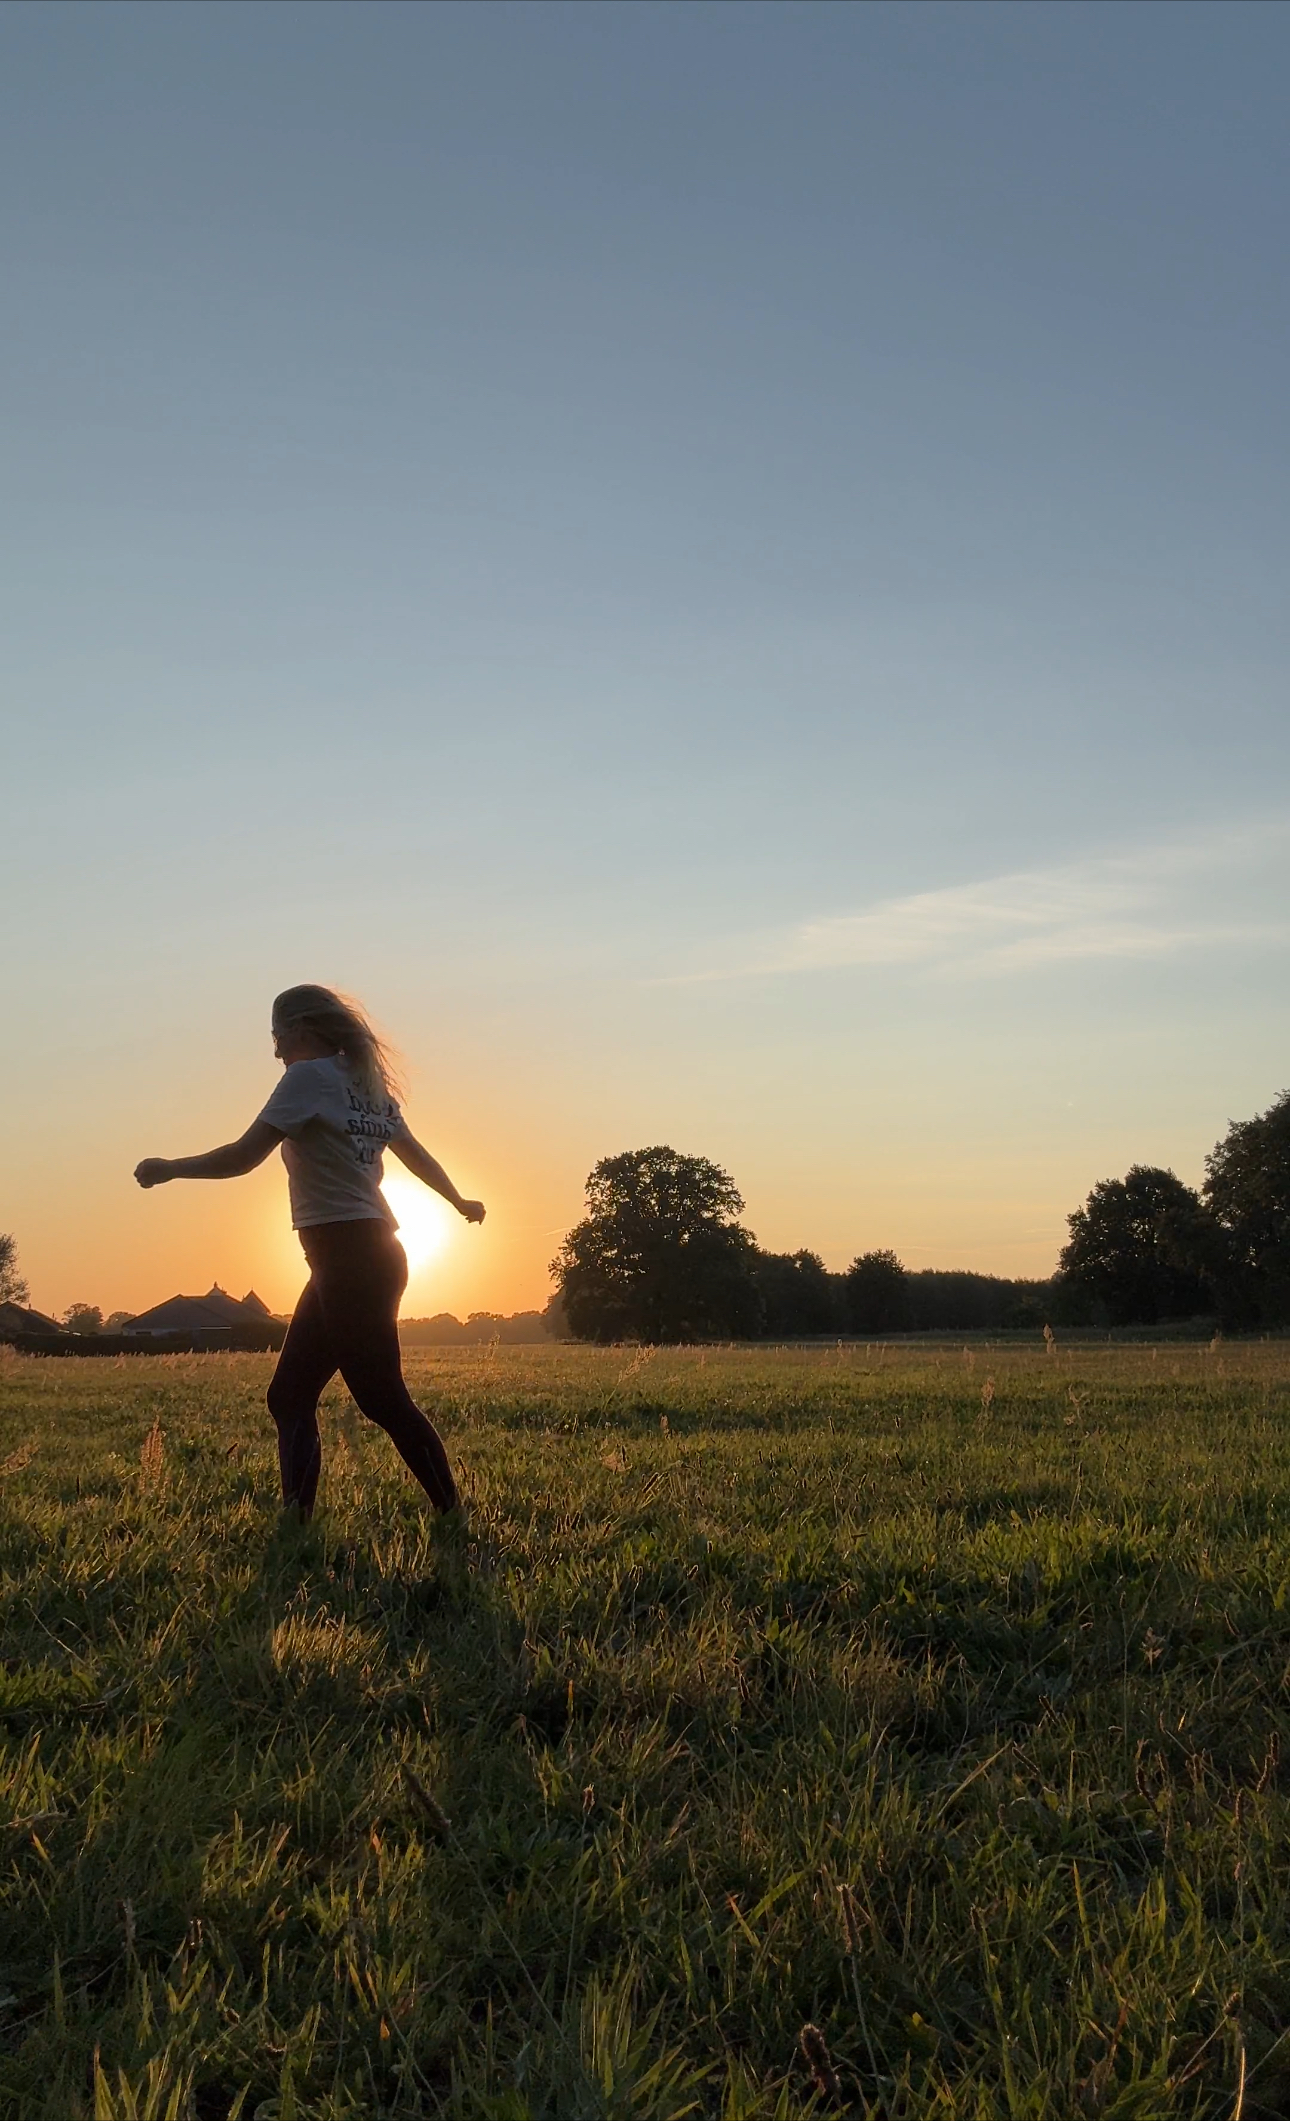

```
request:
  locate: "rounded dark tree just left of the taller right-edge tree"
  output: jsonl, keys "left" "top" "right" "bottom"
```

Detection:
{"left": 1061, "top": 1164, "right": 1220, "bottom": 1326}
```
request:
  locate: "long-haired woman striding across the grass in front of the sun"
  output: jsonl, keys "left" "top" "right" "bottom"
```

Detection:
{"left": 134, "top": 986, "right": 484, "bottom": 1523}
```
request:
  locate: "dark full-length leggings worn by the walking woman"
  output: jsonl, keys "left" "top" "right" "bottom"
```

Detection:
{"left": 269, "top": 1222, "right": 460, "bottom": 1517}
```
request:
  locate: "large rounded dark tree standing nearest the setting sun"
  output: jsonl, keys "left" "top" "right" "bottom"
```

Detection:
{"left": 552, "top": 1147, "right": 760, "bottom": 1343}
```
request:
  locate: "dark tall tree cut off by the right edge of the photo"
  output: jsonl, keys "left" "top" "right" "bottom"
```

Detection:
{"left": 1203, "top": 1090, "right": 1290, "bottom": 1326}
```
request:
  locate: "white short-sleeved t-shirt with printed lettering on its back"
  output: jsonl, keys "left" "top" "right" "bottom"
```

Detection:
{"left": 261, "top": 1054, "right": 407, "bottom": 1230}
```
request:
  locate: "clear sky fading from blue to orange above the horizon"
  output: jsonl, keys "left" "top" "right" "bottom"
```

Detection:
{"left": 0, "top": 0, "right": 1290, "bottom": 1309}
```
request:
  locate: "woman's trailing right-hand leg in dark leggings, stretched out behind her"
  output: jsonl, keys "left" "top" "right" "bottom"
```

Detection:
{"left": 310, "top": 1222, "right": 460, "bottom": 1510}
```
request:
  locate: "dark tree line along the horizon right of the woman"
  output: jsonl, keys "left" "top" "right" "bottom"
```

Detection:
{"left": 547, "top": 1090, "right": 1290, "bottom": 1343}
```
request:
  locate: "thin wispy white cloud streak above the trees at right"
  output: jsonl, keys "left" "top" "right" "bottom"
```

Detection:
{"left": 681, "top": 819, "right": 1290, "bottom": 980}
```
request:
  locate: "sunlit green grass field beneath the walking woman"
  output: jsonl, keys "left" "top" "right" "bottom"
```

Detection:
{"left": 0, "top": 1345, "right": 1290, "bottom": 2121}
